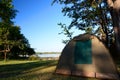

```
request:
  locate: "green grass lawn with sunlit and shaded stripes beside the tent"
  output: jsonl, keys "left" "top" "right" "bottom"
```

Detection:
{"left": 0, "top": 60, "right": 120, "bottom": 80}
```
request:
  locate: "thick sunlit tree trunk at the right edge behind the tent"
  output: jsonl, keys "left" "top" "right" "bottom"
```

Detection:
{"left": 107, "top": 0, "right": 120, "bottom": 55}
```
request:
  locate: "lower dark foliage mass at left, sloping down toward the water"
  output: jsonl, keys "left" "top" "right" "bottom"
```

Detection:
{"left": 0, "top": 26, "right": 35, "bottom": 58}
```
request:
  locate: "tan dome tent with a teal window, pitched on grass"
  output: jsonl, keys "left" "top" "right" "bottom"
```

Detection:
{"left": 55, "top": 34, "right": 118, "bottom": 79}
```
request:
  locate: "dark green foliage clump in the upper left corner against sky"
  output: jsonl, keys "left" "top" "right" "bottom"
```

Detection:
{"left": 0, "top": 0, "right": 17, "bottom": 24}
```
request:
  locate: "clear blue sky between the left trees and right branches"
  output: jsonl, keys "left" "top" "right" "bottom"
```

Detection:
{"left": 13, "top": 0, "right": 80, "bottom": 52}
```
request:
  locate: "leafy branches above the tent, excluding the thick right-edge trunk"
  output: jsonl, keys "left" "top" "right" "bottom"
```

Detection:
{"left": 53, "top": 0, "right": 113, "bottom": 46}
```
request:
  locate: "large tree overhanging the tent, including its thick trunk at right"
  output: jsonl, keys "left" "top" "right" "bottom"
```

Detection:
{"left": 53, "top": 0, "right": 120, "bottom": 52}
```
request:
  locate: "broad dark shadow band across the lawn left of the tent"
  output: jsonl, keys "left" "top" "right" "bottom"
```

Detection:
{"left": 0, "top": 61, "right": 57, "bottom": 78}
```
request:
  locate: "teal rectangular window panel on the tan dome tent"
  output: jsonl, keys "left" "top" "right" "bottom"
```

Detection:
{"left": 74, "top": 40, "right": 92, "bottom": 64}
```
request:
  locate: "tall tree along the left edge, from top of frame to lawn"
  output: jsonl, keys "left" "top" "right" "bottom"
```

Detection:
{"left": 0, "top": 0, "right": 16, "bottom": 60}
